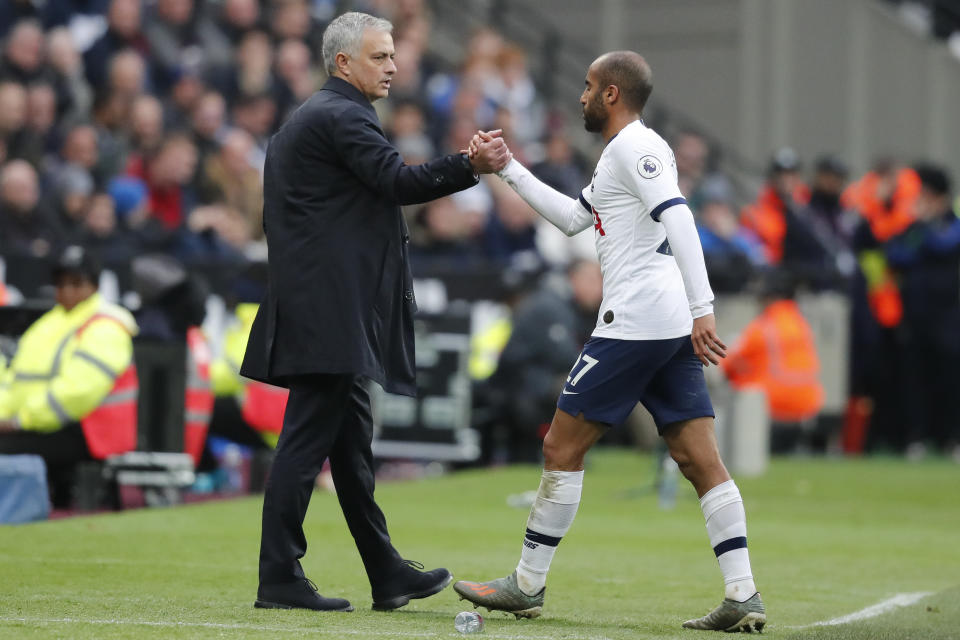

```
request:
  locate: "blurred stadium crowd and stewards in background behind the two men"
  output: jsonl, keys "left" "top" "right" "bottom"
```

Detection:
{"left": 0, "top": 0, "right": 960, "bottom": 482}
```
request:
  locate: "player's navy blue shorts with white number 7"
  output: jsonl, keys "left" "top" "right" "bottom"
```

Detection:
{"left": 557, "top": 336, "right": 714, "bottom": 435}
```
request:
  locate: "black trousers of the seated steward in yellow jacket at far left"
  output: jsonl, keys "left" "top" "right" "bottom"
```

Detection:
{"left": 0, "top": 422, "right": 93, "bottom": 508}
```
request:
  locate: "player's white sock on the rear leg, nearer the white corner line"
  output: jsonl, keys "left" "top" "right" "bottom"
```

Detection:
{"left": 700, "top": 480, "right": 757, "bottom": 602}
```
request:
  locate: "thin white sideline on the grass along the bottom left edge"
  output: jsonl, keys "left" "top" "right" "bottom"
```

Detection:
{"left": 0, "top": 616, "right": 610, "bottom": 640}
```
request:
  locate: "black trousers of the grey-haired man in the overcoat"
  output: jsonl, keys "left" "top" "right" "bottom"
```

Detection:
{"left": 260, "top": 374, "right": 401, "bottom": 584}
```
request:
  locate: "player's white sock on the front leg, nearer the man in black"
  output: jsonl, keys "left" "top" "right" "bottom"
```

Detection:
{"left": 517, "top": 471, "right": 583, "bottom": 596}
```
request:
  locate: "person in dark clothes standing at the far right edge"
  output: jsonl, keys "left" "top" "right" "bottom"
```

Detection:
{"left": 885, "top": 165, "right": 960, "bottom": 459}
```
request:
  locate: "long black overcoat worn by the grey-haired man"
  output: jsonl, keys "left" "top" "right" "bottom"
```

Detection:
{"left": 240, "top": 78, "right": 477, "bottom": 395}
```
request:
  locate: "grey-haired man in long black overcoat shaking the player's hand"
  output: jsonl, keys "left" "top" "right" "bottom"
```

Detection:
{"left": 241, "top": 12, "right": 510, "bottom": 611}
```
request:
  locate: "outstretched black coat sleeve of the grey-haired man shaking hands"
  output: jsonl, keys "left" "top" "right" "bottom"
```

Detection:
{"left": 333, "top": 110, "right": 478, "bottom": 205}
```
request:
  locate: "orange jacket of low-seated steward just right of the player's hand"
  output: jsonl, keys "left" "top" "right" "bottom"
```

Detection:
{"left": 722, "top": 300, "right": 823, "bottom": 422}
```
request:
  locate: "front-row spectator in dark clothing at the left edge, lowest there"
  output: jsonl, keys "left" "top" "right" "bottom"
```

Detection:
{"left": 0, "top": 160, "right": 62, "bottom": 258}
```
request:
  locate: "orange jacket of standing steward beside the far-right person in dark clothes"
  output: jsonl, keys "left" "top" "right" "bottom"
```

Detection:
{"left": 841, "top": 169, "right": 920, "bottom": 242}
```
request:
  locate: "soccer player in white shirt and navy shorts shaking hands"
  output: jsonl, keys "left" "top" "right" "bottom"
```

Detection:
{"left": 454, "top": 51, "right": 766, "bottom": 632}
